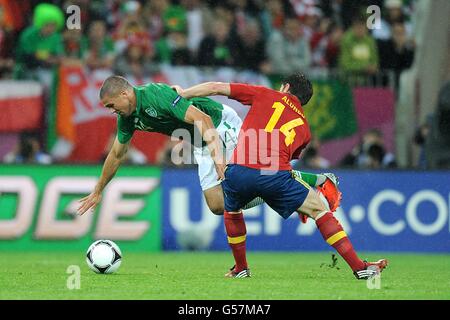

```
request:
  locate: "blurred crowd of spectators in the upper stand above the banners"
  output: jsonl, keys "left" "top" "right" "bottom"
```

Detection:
{"left": 1, "top": 0, "right": 414, "bottom": 78}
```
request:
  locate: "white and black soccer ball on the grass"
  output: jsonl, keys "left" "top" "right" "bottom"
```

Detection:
{"left": 86, "top": 240, "right": 122, "bottom": 273}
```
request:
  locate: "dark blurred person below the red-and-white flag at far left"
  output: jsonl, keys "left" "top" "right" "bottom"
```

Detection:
{"left": 3, "top": 132, "right": 52, "bottom": 164}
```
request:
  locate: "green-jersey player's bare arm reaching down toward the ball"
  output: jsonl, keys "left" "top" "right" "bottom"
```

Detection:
{"left": 77, "top": 137, "right": 129, "bottom": 215}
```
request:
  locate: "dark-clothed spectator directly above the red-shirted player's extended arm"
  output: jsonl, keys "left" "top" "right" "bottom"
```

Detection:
{"left": 198, "top": 18, "right": 234, "bottom": 66}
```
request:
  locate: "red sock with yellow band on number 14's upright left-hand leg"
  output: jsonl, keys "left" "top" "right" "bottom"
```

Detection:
{"left": 223, "top": 211, "right": 247, "bottom": 272}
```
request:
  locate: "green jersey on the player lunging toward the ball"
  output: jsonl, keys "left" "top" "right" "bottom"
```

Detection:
{"left": 117, "top": 83, "right": 223, "bottom": 148}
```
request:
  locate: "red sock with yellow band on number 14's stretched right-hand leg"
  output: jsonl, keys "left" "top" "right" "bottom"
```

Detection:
{"left": 316, "top": 212, "right": 365, "bottom": 271}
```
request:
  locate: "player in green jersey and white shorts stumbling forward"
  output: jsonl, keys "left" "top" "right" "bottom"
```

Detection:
{"left": 78, "top": 76, "right": 337, "bottom": 215}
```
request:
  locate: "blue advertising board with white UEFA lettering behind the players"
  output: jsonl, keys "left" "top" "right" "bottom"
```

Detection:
{"left": 162, "top": 169, "right": 450, "bottom": 252}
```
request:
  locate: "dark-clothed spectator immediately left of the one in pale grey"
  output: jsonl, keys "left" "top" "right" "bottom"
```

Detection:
{"left": 232, "top": 20, "right": 270, "bottom": 73}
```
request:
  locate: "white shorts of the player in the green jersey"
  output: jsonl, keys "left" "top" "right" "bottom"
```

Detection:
{"left": 194, "top": 105, "right": 242, "bottom": 191}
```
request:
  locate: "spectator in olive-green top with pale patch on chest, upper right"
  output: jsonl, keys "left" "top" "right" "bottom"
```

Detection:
{"left": 339, "top": 18, "right": 379, "bottom": 79}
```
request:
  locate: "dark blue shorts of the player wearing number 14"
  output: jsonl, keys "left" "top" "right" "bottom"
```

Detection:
{"left": 222, "top": 164, "right": 310, "bottom": 219}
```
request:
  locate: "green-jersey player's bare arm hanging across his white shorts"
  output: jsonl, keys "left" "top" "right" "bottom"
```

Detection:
{"left": 184, "top": 105, "right": 226, "bottom": 180}
